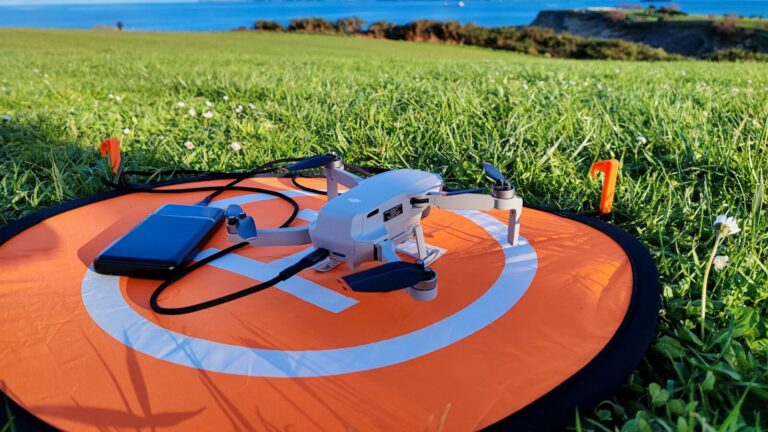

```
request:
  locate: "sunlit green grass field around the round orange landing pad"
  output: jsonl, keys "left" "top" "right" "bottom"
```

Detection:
{"left": 0, "top": 30, "right": 768, "bottom": 432}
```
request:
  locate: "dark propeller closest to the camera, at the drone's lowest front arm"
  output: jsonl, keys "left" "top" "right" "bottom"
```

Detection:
{"left": 342, "top": 261, "right": 435, "bottom": 292}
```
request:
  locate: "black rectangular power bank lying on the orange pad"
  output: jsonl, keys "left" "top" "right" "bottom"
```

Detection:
{"left": 93, "top": 204, "right": 224, "bottom": 279}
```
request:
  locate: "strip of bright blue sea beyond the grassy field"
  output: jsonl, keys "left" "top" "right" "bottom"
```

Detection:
{"left": 0, "top": 0, "right": 768, "bottom": 31}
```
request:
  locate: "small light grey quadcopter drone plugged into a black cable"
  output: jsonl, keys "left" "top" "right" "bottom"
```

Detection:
{"left": 222, "top": 153, "right": 523, "bottom": 300}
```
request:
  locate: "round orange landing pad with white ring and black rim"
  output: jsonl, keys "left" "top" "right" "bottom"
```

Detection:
{"left": 0, "top": 178, "right": 659, "bottom": 431}
